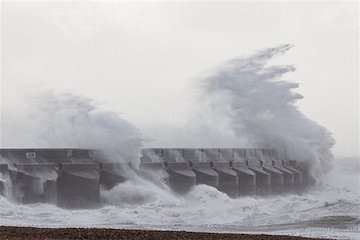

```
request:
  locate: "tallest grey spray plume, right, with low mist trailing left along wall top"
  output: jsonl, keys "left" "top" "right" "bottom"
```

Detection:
{"left": 145, "top": 44, "right": 335, "bottom": 179}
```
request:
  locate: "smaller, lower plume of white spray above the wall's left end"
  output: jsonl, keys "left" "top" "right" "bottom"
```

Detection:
{"left": 2, "top": 91, "right": 142, "bottom": 166}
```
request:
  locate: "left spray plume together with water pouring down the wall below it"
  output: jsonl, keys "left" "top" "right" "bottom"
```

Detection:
{"left": 0, "top": 91, "right": 179, "bottom": 205}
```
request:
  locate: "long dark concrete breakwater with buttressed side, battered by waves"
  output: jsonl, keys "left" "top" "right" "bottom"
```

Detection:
{"left": 0, "top": 148, "right": 314, "bottom": 208}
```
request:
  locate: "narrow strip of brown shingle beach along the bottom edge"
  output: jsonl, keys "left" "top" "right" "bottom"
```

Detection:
{"left": 0, "top": 226, "right": 332, "bottom": 240}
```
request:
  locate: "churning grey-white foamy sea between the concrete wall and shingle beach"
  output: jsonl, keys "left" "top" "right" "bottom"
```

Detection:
{"left": 0, "top": 159, "right": 360, "bottom": 239}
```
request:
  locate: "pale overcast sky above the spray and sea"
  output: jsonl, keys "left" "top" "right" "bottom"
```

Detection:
{"left": 1, "top": 1, "right": 360, "bottom": 155}
